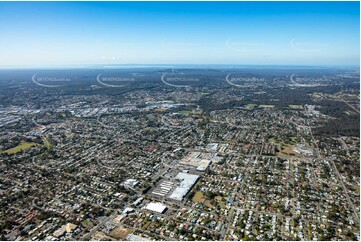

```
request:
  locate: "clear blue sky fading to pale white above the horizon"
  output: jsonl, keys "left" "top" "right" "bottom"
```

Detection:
{"left": 0, "top": 2, "right": 360, "bottom": 66}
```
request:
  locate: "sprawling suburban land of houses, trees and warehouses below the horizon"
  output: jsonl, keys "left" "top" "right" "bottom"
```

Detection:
{"left": 0, "top": 68, "right": 360, "bottom": 241}
